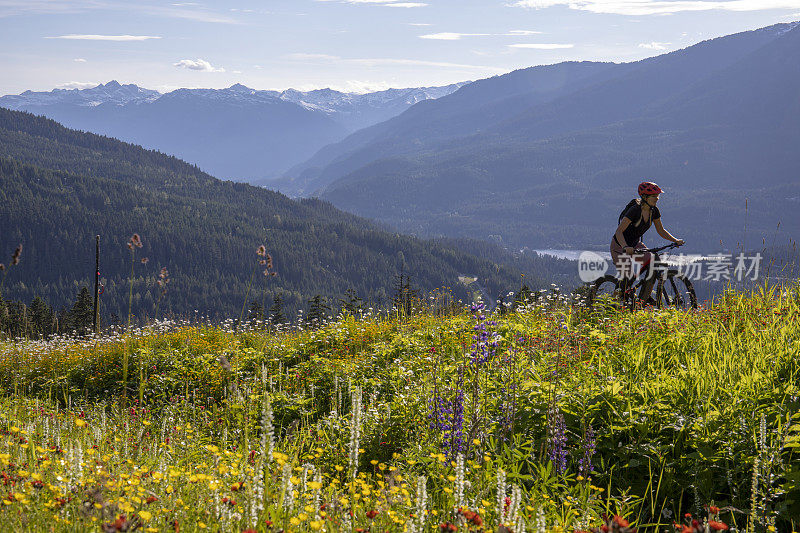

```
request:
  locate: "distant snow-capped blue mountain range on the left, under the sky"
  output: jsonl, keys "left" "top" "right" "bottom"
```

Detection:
{"left": 0, "top": 81, "right": 466, "bottom": 182}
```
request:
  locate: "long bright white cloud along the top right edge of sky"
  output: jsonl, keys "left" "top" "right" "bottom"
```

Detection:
{"left": 507, "top": 0, "right": 800, "bottom": 16}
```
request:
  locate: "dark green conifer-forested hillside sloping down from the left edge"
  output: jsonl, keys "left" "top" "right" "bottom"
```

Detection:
{"left": 0, "top": 104, "right": 572, "bottom": 323}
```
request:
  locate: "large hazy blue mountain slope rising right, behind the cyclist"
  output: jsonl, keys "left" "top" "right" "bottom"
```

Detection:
{"left": 276, "top": 23, "right": 800, "bottom": 251}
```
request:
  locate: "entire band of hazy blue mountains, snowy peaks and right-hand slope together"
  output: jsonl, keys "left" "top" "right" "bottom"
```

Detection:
{"left": 0, "top": 23, "right": 800, "bottom": 258}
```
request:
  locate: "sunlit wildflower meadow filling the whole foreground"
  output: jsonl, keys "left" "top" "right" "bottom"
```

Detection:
{"left": 0, "top": 280, "right": 800, "bottom": 532}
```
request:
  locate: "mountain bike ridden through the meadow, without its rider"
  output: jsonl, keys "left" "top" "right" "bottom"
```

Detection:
{"left": 588, "top": 243, "right": 697, "bottom": 311}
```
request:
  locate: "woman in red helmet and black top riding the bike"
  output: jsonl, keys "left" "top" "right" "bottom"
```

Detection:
{"left": 611, "top": 181, "right": 684, "bottom": 304}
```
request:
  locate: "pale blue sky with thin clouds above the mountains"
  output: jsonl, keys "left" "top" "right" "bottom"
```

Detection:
{"left": 0, "top": 0, "right": 800, "bottom": 94}
